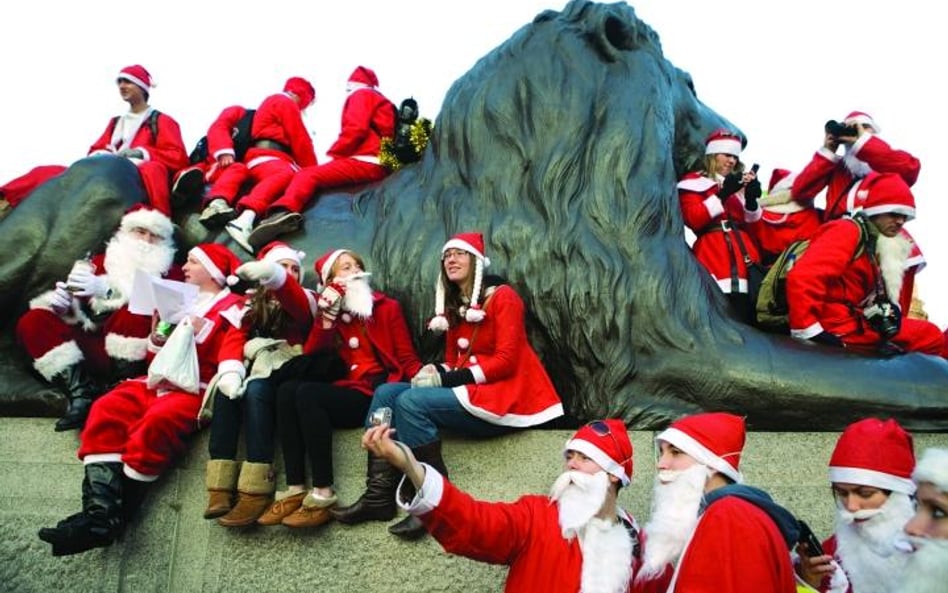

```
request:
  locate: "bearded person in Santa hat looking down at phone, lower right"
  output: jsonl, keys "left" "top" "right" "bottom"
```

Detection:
{"left": 797, "top": 418, "right": 915, "bottom": 593}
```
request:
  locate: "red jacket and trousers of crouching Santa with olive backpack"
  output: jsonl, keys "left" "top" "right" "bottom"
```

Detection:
{"left": 787, "top": 219, "right": 944, "bottom": 355}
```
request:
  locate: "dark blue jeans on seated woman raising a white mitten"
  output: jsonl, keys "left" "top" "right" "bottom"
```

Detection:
{"left": 208, "top": 379, "right": 276, "bottom": 463}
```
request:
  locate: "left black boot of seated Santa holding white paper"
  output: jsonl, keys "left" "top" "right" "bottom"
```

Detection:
{"left": 39, "top": 462, "right": 123, "bottom": 556}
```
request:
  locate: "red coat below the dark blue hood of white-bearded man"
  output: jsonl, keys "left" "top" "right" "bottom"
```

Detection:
{"left": 668, "top": 496, "right": 796, "bottom": 593}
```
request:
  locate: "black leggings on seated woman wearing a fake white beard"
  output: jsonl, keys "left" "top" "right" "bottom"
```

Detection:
{"left": 277, "top": 381, "right": 372, "bottom": 488}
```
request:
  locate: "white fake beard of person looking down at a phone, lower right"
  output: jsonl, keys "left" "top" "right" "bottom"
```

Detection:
{"left": 836, "top": 492, "right": 915, "bottom": 593}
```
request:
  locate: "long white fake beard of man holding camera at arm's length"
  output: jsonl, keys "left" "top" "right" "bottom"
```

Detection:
{"left": 550, "top": 471, "right": 633, "bottom": 593}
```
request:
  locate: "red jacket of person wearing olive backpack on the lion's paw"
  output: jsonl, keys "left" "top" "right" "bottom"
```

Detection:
{"left": 787, "top": 219, "right": 878, "bottom": 339}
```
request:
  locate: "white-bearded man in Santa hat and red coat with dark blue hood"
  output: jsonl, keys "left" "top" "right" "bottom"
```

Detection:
{"left": 635, "top": 412, "right": 799, "bottom": 593}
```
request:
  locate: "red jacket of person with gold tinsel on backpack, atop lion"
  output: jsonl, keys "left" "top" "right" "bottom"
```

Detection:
{"left": 326, "top": 87, "right": 395, "bottom": 164}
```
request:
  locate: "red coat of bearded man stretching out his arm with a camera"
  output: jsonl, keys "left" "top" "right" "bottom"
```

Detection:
{"left": 413, "top": 468, "right": 638, "bottom": 593}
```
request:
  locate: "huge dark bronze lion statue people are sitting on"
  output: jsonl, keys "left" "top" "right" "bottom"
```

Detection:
{"left": 0, "top": 0, "right": 948, "bottom": 431}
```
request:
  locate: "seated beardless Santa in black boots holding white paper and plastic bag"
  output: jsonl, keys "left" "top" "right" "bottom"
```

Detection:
{"left": 39, "top": 243, "right": 244, "bottom": 556}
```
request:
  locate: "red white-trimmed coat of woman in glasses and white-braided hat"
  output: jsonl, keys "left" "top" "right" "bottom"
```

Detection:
{"left": 444, "top": 285, "right": 563, "bottom": 428}
